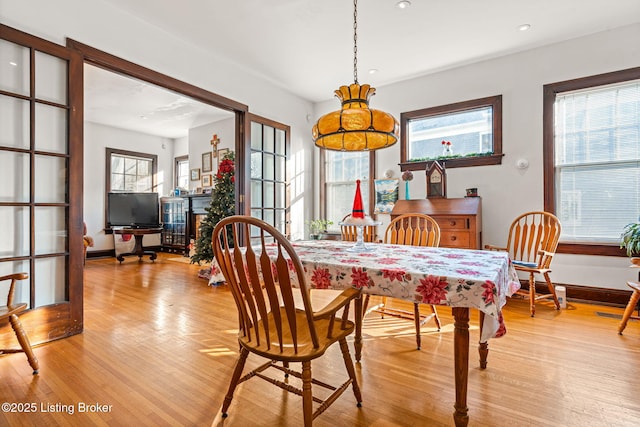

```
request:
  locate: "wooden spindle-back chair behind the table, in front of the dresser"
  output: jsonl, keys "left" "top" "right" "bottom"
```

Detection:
{"left": 364, "top": 214, "right": 441, "bottom": 350}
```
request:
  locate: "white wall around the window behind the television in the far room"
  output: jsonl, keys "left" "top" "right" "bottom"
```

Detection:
{"left": 84, "top": 122, "right": 174, "bottom": 251}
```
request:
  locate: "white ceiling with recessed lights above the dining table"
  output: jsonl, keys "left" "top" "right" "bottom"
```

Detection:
{"left": 86, "top": 0, "right": 640, "bottom": 139}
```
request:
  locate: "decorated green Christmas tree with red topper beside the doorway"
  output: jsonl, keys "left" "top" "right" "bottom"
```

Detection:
{"left": 191, "top": 151, "right": 236, "bottom": 264}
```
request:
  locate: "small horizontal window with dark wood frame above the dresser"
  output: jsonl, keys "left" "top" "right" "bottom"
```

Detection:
{"left": 400, "top": 95, "right": 502, "bottom": 171}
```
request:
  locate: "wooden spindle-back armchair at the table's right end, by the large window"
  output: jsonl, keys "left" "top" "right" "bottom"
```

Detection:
{"left": 485, "top": 211, "right": 562, "bottom": 317}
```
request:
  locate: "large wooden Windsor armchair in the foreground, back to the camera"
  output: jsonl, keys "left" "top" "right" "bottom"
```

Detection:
{"left": 211, "top": 215, "right": 362, "bottom": 426}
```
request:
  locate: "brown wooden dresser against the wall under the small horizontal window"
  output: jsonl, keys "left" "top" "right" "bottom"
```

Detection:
{"left": 391, "top": 197, "right": 482, "bottom": 249}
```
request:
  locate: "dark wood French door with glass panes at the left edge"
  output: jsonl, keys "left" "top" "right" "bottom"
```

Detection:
{"left": 0, "top": 24, "right": 83, "bottom": 347}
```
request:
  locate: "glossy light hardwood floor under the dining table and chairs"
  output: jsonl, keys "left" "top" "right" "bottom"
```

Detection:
{"left": 0, "top": 254, "right": 640, "bottom": 427}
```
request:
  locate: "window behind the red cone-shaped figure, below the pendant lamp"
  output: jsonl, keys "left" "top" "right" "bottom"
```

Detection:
{"left": 320, "top": 150, "right": 375, "bottom": 231}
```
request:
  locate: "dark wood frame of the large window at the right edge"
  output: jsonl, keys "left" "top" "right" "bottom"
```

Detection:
{"left": 542, "top": 67, "right": 640, "bottom": 257}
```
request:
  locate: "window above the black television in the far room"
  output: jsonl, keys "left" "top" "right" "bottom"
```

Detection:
{"left": 104, "top": 148, "right": 158, "bottom": 229}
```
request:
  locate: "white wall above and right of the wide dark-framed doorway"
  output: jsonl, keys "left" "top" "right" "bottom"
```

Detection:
{"left": 0, "top": 0, "right": 313, "bottom": 242}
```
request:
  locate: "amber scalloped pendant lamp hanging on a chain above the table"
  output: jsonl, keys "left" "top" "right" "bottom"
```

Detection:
{"left": 312, "top": 0, "right": 400, "bottom": 151}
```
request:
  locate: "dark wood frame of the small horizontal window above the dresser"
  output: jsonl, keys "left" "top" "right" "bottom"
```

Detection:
{"left": 400, "top": 95, "right": 504, "bottom": 172}
